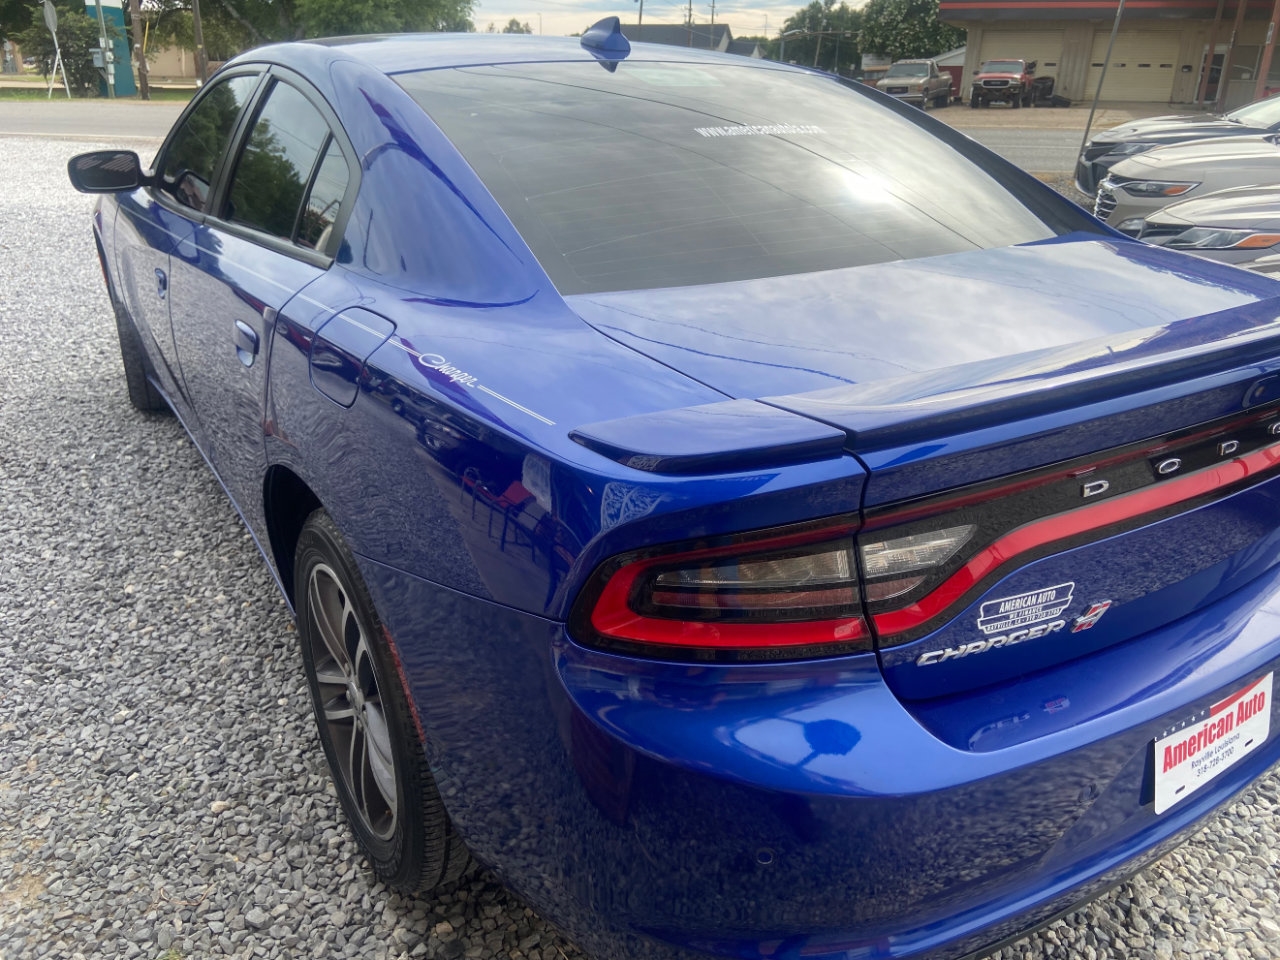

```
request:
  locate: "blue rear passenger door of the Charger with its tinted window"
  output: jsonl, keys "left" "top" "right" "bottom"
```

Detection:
{"left": 169, "top": 74, "right": 351, "bottom": 541}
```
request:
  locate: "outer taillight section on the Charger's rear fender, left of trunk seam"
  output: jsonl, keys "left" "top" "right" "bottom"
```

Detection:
{"left": 573, "top": 521, "right": 870, "bottom": 660}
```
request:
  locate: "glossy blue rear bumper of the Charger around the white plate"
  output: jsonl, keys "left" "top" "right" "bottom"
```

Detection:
{"left": 361, "top": 561, "right": 1280, "bottom": 959}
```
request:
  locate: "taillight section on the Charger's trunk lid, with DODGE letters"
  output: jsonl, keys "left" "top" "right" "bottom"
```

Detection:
{"left": 858, "top": 407, "right": 1280, "bottom": 648}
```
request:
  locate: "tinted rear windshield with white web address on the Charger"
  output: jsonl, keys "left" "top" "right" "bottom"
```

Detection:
{"left": 396, "top": 61, "right": 1069, "bottom": 294}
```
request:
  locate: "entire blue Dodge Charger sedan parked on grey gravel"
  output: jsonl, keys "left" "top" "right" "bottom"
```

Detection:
{"left": 69, "top": 19, "right": 1280, "bottom": 960}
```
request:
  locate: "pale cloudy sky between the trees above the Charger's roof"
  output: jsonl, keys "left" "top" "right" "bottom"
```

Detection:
{"left": 471, "top": 0, "right": 806, "bottom": 37}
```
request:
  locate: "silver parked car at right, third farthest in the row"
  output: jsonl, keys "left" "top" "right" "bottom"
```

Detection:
{"left": 1125, "top": 186, "right": 1280, "bottom": 273}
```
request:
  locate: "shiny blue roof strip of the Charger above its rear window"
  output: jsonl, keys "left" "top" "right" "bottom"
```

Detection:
{"left": 233, "top": 33, "right": 796, "bottom": 76}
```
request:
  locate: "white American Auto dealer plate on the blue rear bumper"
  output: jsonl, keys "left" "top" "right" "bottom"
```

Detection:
{"left": 1156, "top": 673, "right": 1275, "bottom": 813}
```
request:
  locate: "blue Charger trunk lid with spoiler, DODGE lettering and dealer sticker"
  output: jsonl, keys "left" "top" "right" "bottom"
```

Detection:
{"left": 579, "top": 241, "right": 1280, "bottom": 700}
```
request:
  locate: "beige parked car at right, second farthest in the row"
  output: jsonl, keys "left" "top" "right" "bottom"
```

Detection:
{"left": 1093, "top": 134, "right": 1280, "bottom": 234}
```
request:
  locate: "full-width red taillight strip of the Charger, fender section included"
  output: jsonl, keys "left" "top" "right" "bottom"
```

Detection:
{"left": 571, "top": 404, "right": 1280, "bottom": 660}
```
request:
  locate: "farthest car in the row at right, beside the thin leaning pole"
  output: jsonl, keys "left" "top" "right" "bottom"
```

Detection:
{"left": 1075, "top": 96, "right": 1280, "bottom": 196}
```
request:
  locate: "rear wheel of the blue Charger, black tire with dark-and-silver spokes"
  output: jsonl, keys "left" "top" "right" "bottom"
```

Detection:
{"left": 293, "top": 509, "right": 471, "bottom": 893}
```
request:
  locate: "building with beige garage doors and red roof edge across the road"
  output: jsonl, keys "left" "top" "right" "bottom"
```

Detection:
{"left": 940, "top": 0, "right": 1280, "bottom": 108}
